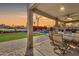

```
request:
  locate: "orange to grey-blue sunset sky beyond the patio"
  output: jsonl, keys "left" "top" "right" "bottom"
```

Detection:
{"left": 0, "top": 3, "right": 54, "bottom": 26}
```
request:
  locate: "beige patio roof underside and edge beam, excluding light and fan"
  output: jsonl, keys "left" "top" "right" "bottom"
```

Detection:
{"left": 31, "top": 3, "right": 79, "bottom": 23}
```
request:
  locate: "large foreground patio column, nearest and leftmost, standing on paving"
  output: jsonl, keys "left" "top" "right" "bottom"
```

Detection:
{"left": 25, "top": 3, "right": 33, "bottom": 56}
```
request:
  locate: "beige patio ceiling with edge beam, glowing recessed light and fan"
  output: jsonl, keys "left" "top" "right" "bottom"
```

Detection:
{"left": 33, "top": 3, "right": 79, "bottom": 23}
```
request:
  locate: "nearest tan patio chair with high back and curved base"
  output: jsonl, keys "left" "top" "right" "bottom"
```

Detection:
{"left": 53, "top": 34, "right": 67, "bottom": 55}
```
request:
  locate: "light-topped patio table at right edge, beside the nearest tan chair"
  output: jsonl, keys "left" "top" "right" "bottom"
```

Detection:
{"left": 63, "top": 33, "right": 79, "bottom": 47}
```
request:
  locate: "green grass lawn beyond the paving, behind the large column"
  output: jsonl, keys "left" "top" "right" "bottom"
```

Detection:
{"left": 0, "top": 32, "right": 43, "bottom": 42}
